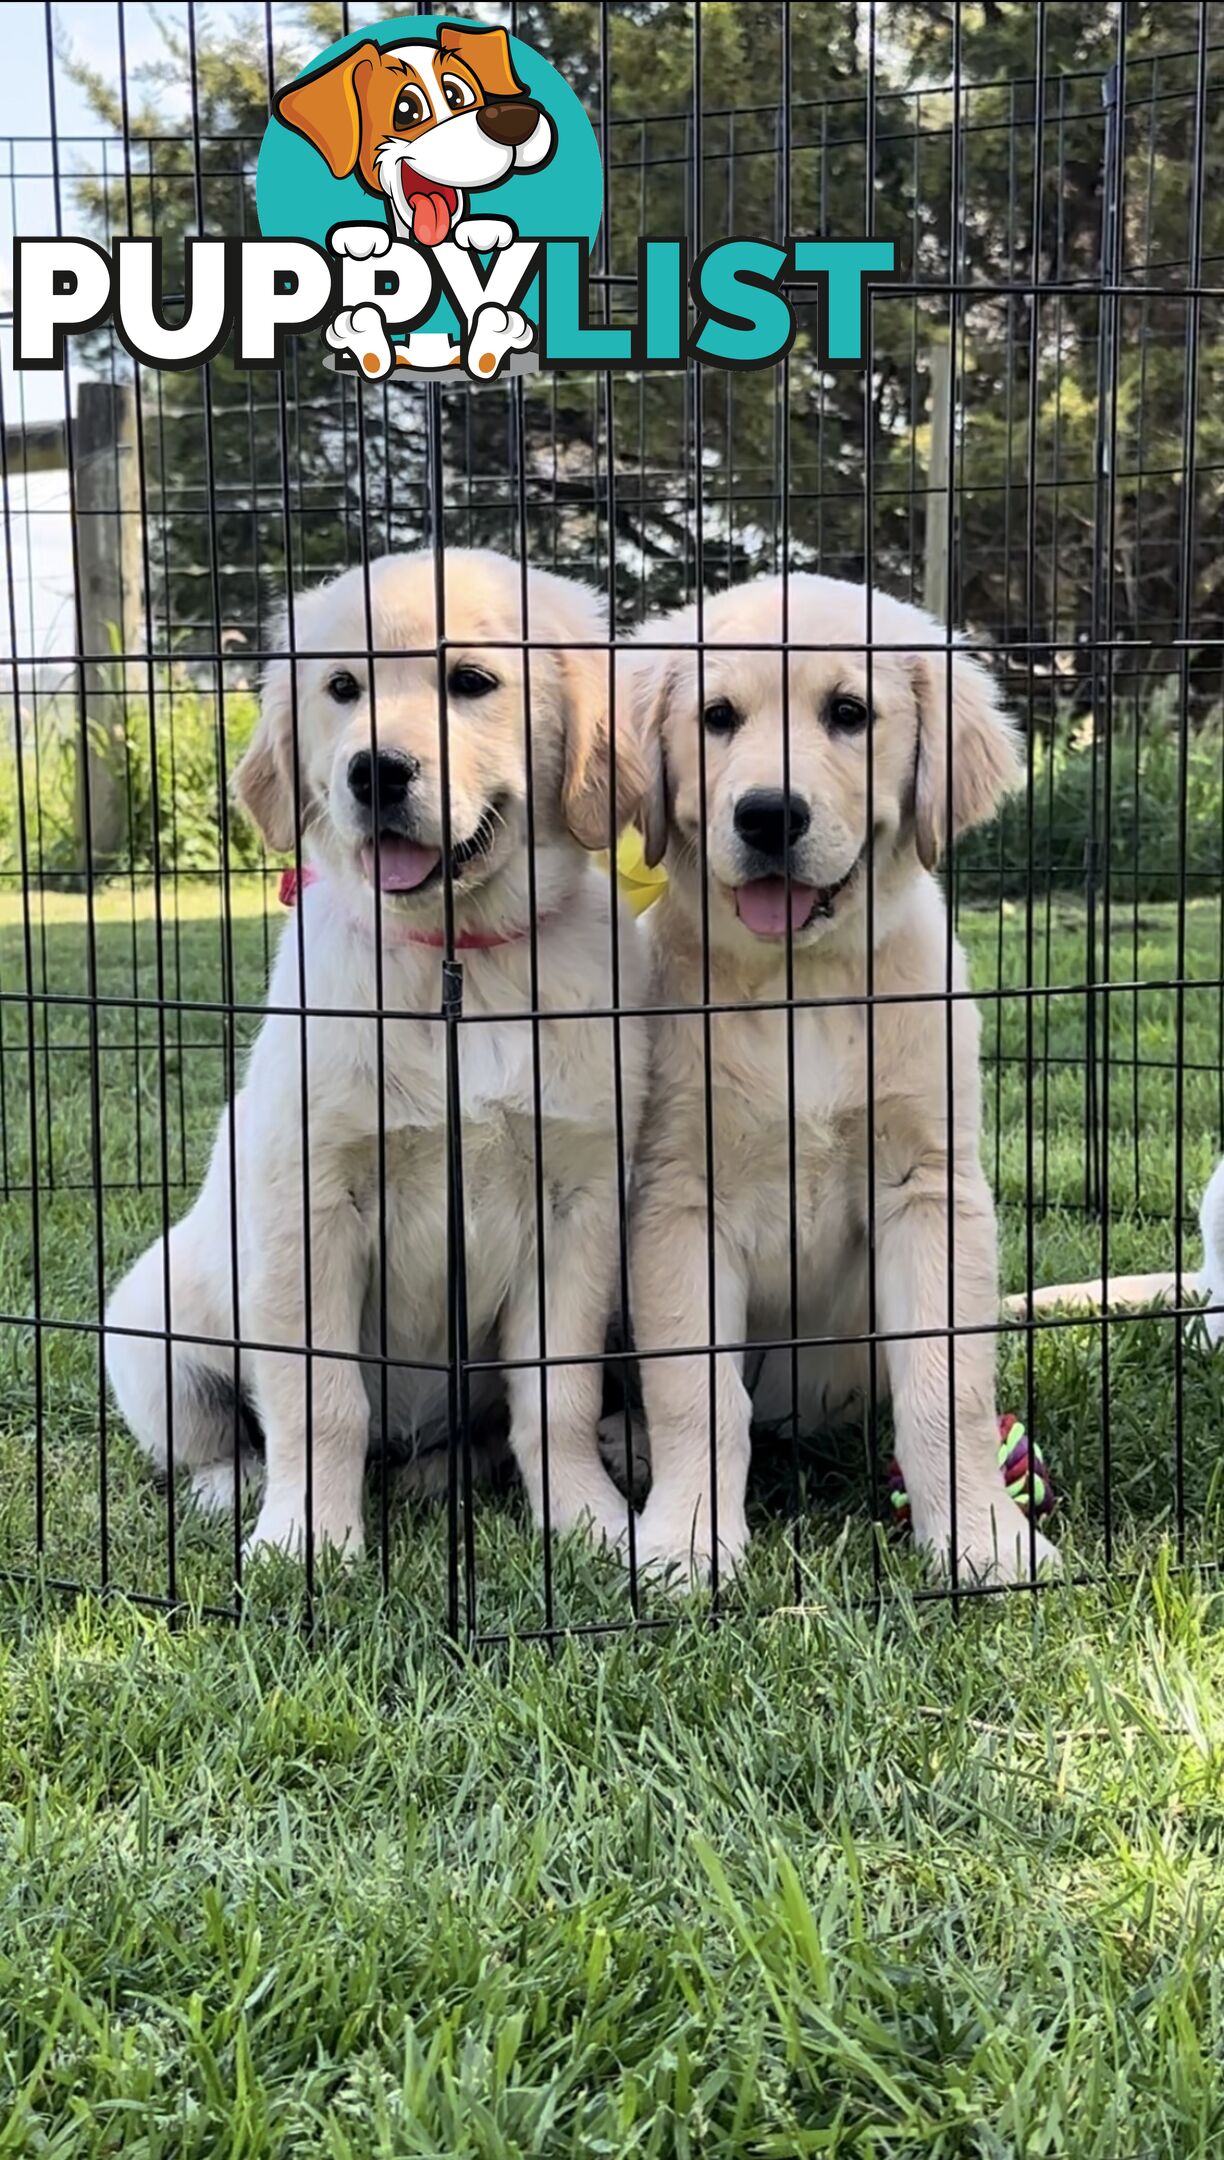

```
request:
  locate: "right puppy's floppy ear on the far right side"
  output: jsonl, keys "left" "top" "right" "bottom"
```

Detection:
{"left": 911, "top": 646, "right": 1021, "bottom": 870}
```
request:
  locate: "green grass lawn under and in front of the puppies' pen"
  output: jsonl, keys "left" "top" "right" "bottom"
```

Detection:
{"left": 0, "top": 883, "right": 1224, "bottom": 2160}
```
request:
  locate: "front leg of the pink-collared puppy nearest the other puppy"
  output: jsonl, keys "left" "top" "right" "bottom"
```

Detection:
{"left": 501, "top": 1182, "right": 628, "bottom": 1542}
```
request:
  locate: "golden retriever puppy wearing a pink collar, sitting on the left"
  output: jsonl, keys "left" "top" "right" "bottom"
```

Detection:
{"left": 106, "top": 551, "right": 648, "bottom": 1555}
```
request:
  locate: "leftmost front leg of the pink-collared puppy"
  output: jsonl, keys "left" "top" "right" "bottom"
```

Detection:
{"left": 242, "top": 1169, "right": 369, "bottom": 1560}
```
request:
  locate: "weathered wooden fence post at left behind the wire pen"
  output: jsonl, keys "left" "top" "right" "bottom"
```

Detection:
{"left": 73, "top": 382, "right": 145, "bottom": 870}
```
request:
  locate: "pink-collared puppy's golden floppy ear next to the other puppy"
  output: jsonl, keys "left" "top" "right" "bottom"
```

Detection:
{"left": 529, "top": 570, "right": 645, "bottom": 849}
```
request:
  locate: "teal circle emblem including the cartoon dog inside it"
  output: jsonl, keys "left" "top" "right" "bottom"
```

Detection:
{"left": 255, "top": 15, "right": 604, "bottom": 380}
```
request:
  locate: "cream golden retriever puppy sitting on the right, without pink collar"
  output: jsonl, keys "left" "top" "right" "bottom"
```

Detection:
{"left": 626, "top": 575, "right": 1051, "bottom": 1577}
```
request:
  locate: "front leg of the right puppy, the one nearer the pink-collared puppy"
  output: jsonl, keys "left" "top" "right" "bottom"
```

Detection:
{"left": 633, "top": 1190, "right": 751, "bottom": 1581}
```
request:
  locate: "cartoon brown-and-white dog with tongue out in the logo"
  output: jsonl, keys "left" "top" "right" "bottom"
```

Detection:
{"left": 272, "top": 24, "right": 557, "bottom": 376}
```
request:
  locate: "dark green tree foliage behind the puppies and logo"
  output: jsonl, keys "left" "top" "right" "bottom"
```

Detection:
{"left": 64, "top": 0, "right": 1224, "bottom": 719}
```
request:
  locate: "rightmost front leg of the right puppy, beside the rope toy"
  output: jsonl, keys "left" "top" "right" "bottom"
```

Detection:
{"left": 876, "top": 1158, "right": 1058, "bottom": 1581}
